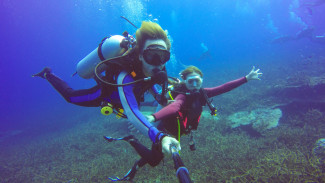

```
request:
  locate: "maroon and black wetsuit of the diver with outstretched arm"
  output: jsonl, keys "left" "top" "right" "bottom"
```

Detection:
{"left": 117, "top": 77, "right": 247, "bottom": 176}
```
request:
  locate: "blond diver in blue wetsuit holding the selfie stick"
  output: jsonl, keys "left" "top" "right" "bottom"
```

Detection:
{"left": 33, "top": 21, "right": 180, "bottom": 154}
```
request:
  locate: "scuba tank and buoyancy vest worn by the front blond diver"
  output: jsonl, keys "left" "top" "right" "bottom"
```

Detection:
{"left": 76, "top": 31, "right": 167, "bottom": 114}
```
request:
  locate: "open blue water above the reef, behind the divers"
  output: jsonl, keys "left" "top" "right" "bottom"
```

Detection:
{"left": 0, "top": 0, "right": 325, "bottom": 146}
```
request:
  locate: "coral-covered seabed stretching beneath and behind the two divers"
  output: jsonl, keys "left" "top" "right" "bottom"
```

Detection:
{"left": 0, "top": 57, "right": 325, "bottom": 183}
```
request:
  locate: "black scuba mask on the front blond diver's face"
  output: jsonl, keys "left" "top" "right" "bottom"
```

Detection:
{"left": 143, "top": 49, "right": 170, "bottom": 66}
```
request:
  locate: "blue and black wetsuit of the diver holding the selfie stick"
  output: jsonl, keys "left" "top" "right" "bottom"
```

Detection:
{"left": 46, "top": 67, "right": 164, "bottom": 143}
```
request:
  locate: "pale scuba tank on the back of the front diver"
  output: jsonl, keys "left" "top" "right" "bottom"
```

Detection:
{"left": 77, "top": 32, "right": 135, "bottom": 79}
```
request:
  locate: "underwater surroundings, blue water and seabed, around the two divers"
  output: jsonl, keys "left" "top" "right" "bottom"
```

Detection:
{"left": 0, "top": 0, "right": 325, "bottom": 183}
